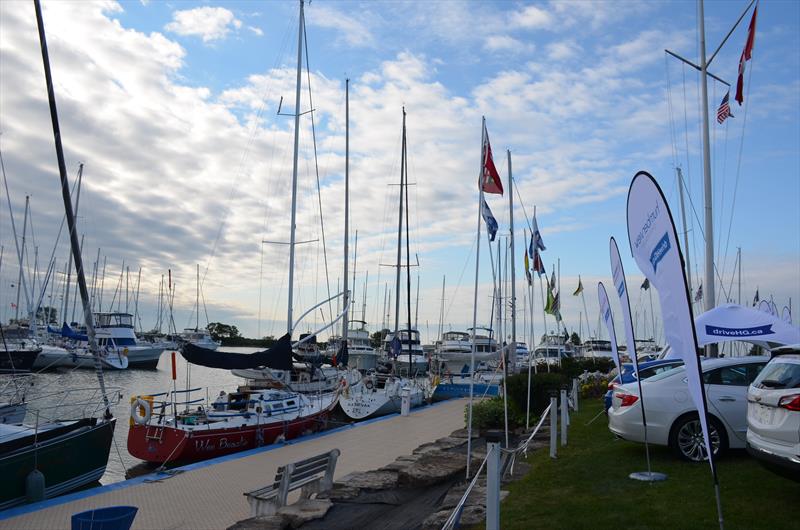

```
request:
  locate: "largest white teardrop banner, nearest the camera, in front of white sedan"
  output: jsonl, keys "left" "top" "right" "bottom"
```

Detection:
{"left": 628, "top": 171, "right": 722, "bottom": 527}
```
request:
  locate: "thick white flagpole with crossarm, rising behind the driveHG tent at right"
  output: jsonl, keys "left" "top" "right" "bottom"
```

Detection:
{"left": 696, "top": 0, "right": 717, "bottom": 357}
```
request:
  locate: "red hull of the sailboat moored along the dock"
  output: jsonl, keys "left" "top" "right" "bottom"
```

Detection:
{"left": 128, "top": 409, "right": 330, "bottom": 464}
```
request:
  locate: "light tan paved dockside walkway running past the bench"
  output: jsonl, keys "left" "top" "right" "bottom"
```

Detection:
{"left": 0, "top": 399, "right": 466, "bottom": 530}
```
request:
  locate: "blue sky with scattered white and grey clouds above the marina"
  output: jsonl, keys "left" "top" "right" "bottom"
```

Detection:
{"left": 0, "top": 0, "right": 800, "bottom": 342}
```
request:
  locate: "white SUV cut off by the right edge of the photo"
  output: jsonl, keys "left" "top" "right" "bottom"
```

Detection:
{"left": 747, "top": 347, "right": 800, "bottom": 480}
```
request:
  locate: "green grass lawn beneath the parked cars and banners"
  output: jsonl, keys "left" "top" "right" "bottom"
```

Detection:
{"left": 500, "top": 400, "right": 800, "bottom": 530}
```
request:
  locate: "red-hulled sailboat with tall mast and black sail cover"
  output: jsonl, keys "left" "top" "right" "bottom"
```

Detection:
{"left": 128, "top": 0, "right": 347, "bottom": 463}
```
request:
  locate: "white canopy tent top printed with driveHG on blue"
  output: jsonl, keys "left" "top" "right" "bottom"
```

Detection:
{"left": 695, "top": 304, "right": 800, "bottom": 349}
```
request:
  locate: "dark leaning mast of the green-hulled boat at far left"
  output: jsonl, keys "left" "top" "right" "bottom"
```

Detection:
{"left": 34, "top": 0, "right": 111, "bottom": 406}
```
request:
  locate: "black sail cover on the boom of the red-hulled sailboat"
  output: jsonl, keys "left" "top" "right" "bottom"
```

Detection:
{"left": 181, "top": 333, "right": 292, "bottom": 370}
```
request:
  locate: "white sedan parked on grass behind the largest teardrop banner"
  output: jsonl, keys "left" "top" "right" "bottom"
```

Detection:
{"left": 608, "top": 357, "right": 769, "bottom": 462}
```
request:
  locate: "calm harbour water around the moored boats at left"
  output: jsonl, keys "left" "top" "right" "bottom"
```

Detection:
{"left": 0, "top": 348, "right": 260, "bottom": 484}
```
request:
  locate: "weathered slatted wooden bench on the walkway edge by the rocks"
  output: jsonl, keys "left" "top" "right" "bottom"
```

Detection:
{"left": 244, "top": 449, "right": 340, "bottom": 517}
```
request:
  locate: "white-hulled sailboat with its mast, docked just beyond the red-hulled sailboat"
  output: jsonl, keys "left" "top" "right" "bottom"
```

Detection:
{"left": 339, "top": 108, "right": 428, "bottom": 420}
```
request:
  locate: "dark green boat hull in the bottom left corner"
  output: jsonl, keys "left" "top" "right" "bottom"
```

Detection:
{"left": 0, "top": 419, "right": 116, "bottom": 510}
